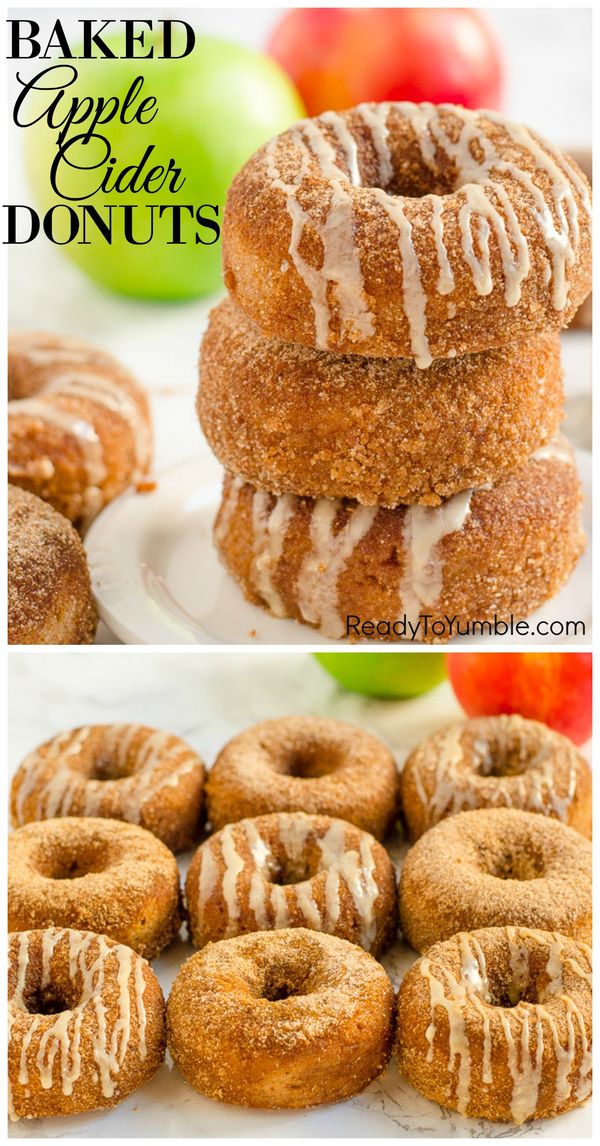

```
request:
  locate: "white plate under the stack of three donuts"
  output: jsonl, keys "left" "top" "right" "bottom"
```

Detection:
{"left": 86, "top": 450, "right": 592, "bottom": 649}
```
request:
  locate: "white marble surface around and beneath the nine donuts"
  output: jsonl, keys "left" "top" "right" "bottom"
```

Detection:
{"left": 8, "top": 649, "right": 591, "bottom": 1139}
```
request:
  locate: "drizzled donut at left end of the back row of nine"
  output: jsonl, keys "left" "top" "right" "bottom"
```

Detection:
{"left": 10, "top": 724, "right": 205, "bottom": 851}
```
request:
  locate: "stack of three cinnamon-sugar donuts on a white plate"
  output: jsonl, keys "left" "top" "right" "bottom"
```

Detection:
{"left": 197, "top": 103, "right": 591, "bottom": 641}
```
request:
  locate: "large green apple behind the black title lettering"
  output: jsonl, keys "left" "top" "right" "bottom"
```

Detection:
{"left": 23, "top": 34, "right": 305, "bottom": 299}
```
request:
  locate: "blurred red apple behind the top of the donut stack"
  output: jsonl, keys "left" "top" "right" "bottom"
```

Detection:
{"left": 267, "top": 8, "right": 503, "bottom": 116}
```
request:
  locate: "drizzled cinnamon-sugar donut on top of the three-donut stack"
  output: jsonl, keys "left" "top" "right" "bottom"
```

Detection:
{"left": 222, "top": 103, "right": 592, "bottom": 368}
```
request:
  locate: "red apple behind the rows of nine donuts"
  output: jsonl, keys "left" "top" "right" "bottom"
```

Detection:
{"left": 447, "top": 652, "right": 592, "bottom": 744}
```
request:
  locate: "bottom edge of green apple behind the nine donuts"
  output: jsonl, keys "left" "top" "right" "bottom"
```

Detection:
{"left": 314, "top": 652, "right": 445, "bottom": 699}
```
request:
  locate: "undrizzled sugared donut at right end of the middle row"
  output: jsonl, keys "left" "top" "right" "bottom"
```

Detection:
{"left": 400, "top": 808, "right": 592, "bottom": 951}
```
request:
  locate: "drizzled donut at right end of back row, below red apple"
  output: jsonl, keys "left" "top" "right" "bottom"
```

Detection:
{"left": 400, "top": 715, "right": 592, "bottom": 840}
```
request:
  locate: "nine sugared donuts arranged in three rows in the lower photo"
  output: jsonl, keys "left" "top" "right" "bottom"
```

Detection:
{"left": 8, "top": 716, "right": 592, "bottom": 1124}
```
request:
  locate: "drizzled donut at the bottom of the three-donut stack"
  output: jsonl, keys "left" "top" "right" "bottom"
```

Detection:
{"left": 214, "top": 439, "right": 585, "bottom": 642}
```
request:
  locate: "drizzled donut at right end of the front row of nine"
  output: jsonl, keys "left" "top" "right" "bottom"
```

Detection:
{"left": 395, "top": 927, "right": 592, "bottom": 1125}
